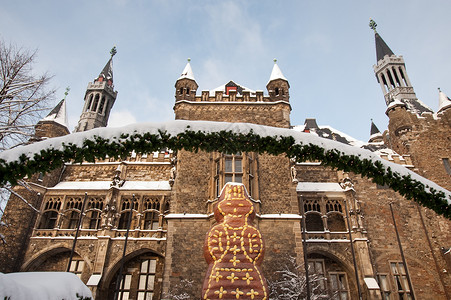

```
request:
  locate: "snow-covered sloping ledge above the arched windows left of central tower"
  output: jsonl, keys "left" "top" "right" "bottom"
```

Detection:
{"left": 49, "top": 181, "right": 171, "bottom": 191}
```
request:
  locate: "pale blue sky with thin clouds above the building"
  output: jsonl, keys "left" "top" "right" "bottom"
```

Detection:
{"left": 0, "top": 0, "right": 451, "bottom": 141}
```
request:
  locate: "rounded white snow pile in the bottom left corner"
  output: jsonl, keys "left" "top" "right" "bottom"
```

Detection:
{"left": 0, "top": 272, "right": 92, "bottom": 300}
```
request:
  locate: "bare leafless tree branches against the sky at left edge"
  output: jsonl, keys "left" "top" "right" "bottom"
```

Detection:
{"left": 0, "top": 40, "right": 55, "bottom": 151}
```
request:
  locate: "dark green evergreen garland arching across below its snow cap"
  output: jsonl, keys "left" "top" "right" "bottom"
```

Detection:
{"left": 0, "top": 126, "right": 451, "bottom": 219}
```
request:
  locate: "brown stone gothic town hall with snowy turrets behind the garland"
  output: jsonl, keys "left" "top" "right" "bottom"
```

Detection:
{"left": 0, "top": 27, "right": 451, "bottom": 300}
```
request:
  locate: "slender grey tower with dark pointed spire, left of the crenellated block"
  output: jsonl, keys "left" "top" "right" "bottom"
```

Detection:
{"left": 74, "top": 47, "right": 117, "bottom": 132}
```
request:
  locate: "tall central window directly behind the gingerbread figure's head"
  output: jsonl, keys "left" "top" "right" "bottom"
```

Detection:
{"left": 211, "top": 153, "right": 258, "bottom": 199}
